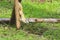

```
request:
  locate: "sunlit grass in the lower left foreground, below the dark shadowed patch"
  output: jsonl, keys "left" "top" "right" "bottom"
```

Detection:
{"left": 0, "top": 24, "right": 46, "bottom": 40}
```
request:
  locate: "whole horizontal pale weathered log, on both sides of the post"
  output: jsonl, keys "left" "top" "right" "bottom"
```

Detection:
{"left": 0, "top": 18, "right": 60, "bottom": 23}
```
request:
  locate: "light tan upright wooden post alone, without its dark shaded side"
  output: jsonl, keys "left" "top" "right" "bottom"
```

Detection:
{"left": 14, "top": 0, "right": 21, "bottom": 29}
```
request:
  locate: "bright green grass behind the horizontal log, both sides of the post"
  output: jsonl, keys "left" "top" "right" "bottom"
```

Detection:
{"left": 0, "top": 1, "right": 60, "bottom": 18}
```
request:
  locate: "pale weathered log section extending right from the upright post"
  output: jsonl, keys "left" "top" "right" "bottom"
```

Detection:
{"left": 27, "top": 18, "right": 60, "bottom": 23}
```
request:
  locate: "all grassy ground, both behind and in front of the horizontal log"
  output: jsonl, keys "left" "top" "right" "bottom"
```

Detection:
{"left": 0, "top": 1, "right": 60, "bottom": 40}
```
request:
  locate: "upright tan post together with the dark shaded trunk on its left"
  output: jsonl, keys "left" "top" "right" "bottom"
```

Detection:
{"left": 10, "top": 0, "right": 21, "bottom": 29}
